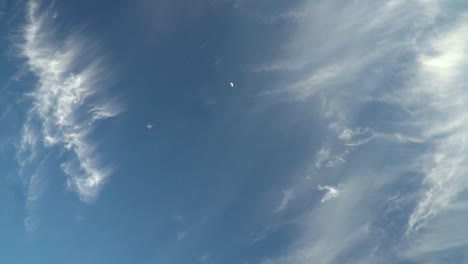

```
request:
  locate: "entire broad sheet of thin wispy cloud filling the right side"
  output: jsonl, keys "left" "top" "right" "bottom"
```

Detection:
{"left": 256, "top": 0, "right": 468, "bottom": 263}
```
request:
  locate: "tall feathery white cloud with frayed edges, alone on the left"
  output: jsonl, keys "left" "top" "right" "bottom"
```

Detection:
{"left": 16, "top": 0, "right": 121, "bottom": 207}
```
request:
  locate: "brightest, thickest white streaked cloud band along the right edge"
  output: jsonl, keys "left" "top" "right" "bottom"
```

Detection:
{"left": 401, "top": 14, "right": 468, "bottom": 255}
